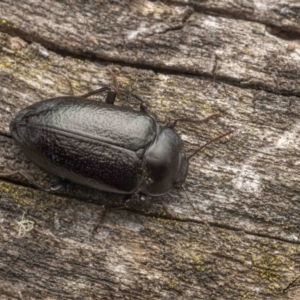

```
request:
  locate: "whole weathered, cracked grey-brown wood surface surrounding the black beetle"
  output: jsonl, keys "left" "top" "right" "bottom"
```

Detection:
{"left": 0, "top": 0, "right": 300, "bottom": 299}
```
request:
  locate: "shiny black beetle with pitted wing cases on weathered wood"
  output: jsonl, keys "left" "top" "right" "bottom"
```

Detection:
{"left": 2, "top": 86, "right": 232, "bottom": 219}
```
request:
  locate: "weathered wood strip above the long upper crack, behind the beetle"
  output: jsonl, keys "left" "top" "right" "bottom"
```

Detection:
{"left": 0, "top": 0, "right": 300, "bottom": 95}
